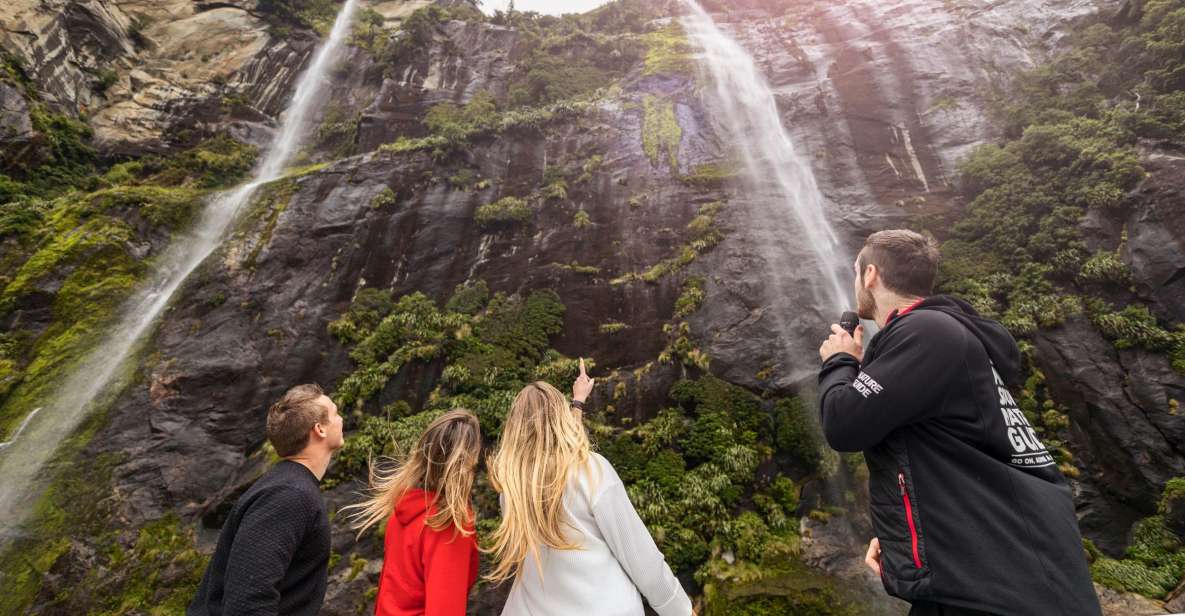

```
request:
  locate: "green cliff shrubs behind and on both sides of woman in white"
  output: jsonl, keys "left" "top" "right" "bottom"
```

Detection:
{"left": 329, "top": 274, "right": 847, "bottom": 614}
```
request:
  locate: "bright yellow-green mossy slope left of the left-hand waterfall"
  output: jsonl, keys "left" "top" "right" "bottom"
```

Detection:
{"left": 0, "top": 131, "right": 255, "bottom": 438}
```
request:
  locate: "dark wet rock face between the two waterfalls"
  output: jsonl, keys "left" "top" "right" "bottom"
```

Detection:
{"left": 94, "top": 104, "right": 712, "bottom": 520}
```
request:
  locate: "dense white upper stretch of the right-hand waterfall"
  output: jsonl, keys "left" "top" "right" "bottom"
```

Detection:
{"left": 683, "top": 0, "right": 851, "bottom": 319}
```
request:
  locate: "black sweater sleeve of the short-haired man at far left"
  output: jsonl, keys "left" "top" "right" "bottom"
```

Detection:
{"left": 223, "top": 486, "right": 314, "bottom": 616}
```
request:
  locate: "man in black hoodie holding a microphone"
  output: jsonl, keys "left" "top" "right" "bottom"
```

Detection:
{"left": 819, "top": 230, "right": 1101, "bottom": 616}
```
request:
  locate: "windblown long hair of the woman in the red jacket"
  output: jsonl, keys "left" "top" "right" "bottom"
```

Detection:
{"left": 345, "top": 409, "right": 481, "bottom": 535}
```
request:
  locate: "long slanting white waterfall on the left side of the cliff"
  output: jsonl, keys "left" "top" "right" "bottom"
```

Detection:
{"left": 0, "top": 0, "right": 358, "bottom": 543}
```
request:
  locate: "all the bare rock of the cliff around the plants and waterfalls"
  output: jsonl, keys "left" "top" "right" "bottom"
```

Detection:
{"left": 0, "top": 0, "right": 1185, "bottom": 614}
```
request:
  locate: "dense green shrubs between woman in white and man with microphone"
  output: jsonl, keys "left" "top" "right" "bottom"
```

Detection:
{"left": 590, "top": 376, "right": 824, "bottom": 612}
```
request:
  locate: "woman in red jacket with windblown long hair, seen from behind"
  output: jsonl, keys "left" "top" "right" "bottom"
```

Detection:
{"left": 351, "top": 409, "right": 481, "bottom": 616}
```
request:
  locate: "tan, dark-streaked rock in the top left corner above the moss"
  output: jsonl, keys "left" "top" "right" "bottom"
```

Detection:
{"left": 0, "top": 0, "right": 316, "bottom": 155}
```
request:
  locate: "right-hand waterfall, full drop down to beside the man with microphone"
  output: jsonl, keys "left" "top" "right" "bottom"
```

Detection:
{"left": 683, "top": 5, "right": 892, "bottom": 612}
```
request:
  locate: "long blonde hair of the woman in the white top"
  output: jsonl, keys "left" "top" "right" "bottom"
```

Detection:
{"left": 486, "top": 381, "right": 590, "bottom": 582}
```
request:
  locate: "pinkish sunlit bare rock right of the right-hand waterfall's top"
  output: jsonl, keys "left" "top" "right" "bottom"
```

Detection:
{"left": 710, "top": 0, "right": 1121, "bottom": 205}
